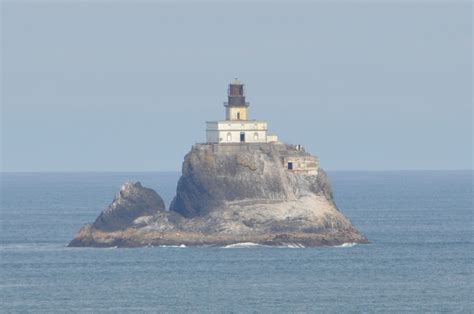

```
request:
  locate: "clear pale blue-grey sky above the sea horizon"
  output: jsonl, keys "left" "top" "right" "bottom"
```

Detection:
{"left": 0, "top": 1, "right": 474, "bottom": 171}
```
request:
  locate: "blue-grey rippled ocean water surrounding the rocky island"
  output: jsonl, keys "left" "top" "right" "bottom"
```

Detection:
{"left": 0, "top": 171, "right": 474, "bottom": 313}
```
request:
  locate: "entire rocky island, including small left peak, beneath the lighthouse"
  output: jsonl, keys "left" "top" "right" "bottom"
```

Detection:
{"left": 70, "top": 143, "right": 367, "bottom": 247}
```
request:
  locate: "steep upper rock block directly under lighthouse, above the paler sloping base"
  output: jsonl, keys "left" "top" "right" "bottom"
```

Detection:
{"left": 170, "top": 143, "right": 332, "bottom": 217}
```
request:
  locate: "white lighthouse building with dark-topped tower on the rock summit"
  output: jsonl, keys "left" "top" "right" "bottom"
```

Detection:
{"left": 206, "top": 79, "right": 278, "bottom": 143}
